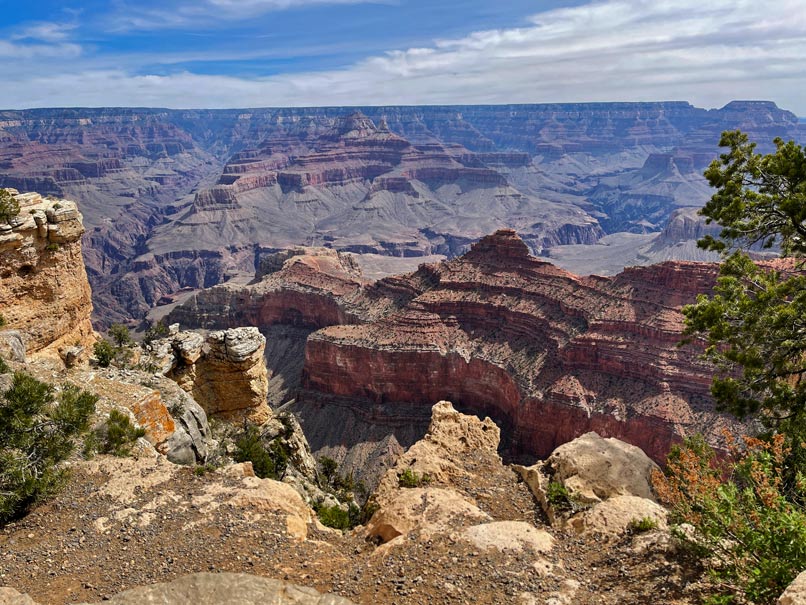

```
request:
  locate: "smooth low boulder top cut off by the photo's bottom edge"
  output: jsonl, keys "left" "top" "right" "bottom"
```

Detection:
{"left": 77, "top": 573, "right": 352, "bottom": 605}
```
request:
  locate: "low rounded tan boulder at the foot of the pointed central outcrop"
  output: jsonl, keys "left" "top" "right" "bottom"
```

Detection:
{"left": 367, "top": 487, "right": 491, "bottom": 542}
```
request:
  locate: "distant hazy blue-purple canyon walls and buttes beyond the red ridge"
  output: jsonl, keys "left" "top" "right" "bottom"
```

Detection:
{"left": 0, "top": 101, "right": 806, "bottom": 328}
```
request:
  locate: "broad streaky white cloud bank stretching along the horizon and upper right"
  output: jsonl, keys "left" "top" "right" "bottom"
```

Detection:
{"left": 0, "top": 0, "right": 806, "bottom": 115}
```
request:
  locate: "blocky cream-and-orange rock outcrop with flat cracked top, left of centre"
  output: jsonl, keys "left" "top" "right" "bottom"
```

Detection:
{"left": 148, "top": 324, "right": 271, "bottom": 424}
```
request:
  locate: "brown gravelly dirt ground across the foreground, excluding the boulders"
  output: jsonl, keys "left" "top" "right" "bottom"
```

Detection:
{"left": 0, "top": 444, "right": 700, "bottom": 605}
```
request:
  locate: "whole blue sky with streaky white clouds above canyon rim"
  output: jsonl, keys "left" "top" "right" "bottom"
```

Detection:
{"left": 0, "top": 0, "right": 806, "bottom": 116}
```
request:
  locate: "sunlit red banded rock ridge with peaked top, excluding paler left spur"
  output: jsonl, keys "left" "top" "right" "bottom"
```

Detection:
{"left": 303, "top": 231, "right": 725, "bottom": 460}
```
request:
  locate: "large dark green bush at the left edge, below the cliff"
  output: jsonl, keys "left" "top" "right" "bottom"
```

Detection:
{"left": 0, "top": 372, "right": 98, "bottom": 524}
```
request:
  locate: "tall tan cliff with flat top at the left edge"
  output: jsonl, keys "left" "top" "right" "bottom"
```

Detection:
{"left": 0, "top": 189, "right": 95, "bottom": 356}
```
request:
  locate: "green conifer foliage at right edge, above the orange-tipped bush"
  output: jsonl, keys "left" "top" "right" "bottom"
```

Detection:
{"left": 683, "top": 131, "right": 806, "bottom": 434}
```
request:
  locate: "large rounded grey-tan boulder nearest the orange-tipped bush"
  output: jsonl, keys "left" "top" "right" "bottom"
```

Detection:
{"left": 544, "top": 433, "right": 658, "bottom": 502}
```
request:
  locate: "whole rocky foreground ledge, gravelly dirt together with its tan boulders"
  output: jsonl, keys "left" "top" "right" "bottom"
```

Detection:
{"left": 0, "top": 402, "right": 803, "bottom": 605}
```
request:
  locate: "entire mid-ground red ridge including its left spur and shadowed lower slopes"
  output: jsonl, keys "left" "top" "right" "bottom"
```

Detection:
{"left": 168, "top": 230, "right": 738, "bottom": 478}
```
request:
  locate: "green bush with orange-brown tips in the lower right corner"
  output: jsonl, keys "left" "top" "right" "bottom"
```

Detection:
{"left": 653, "top": 434, "right": 806, "bottom": 605}
